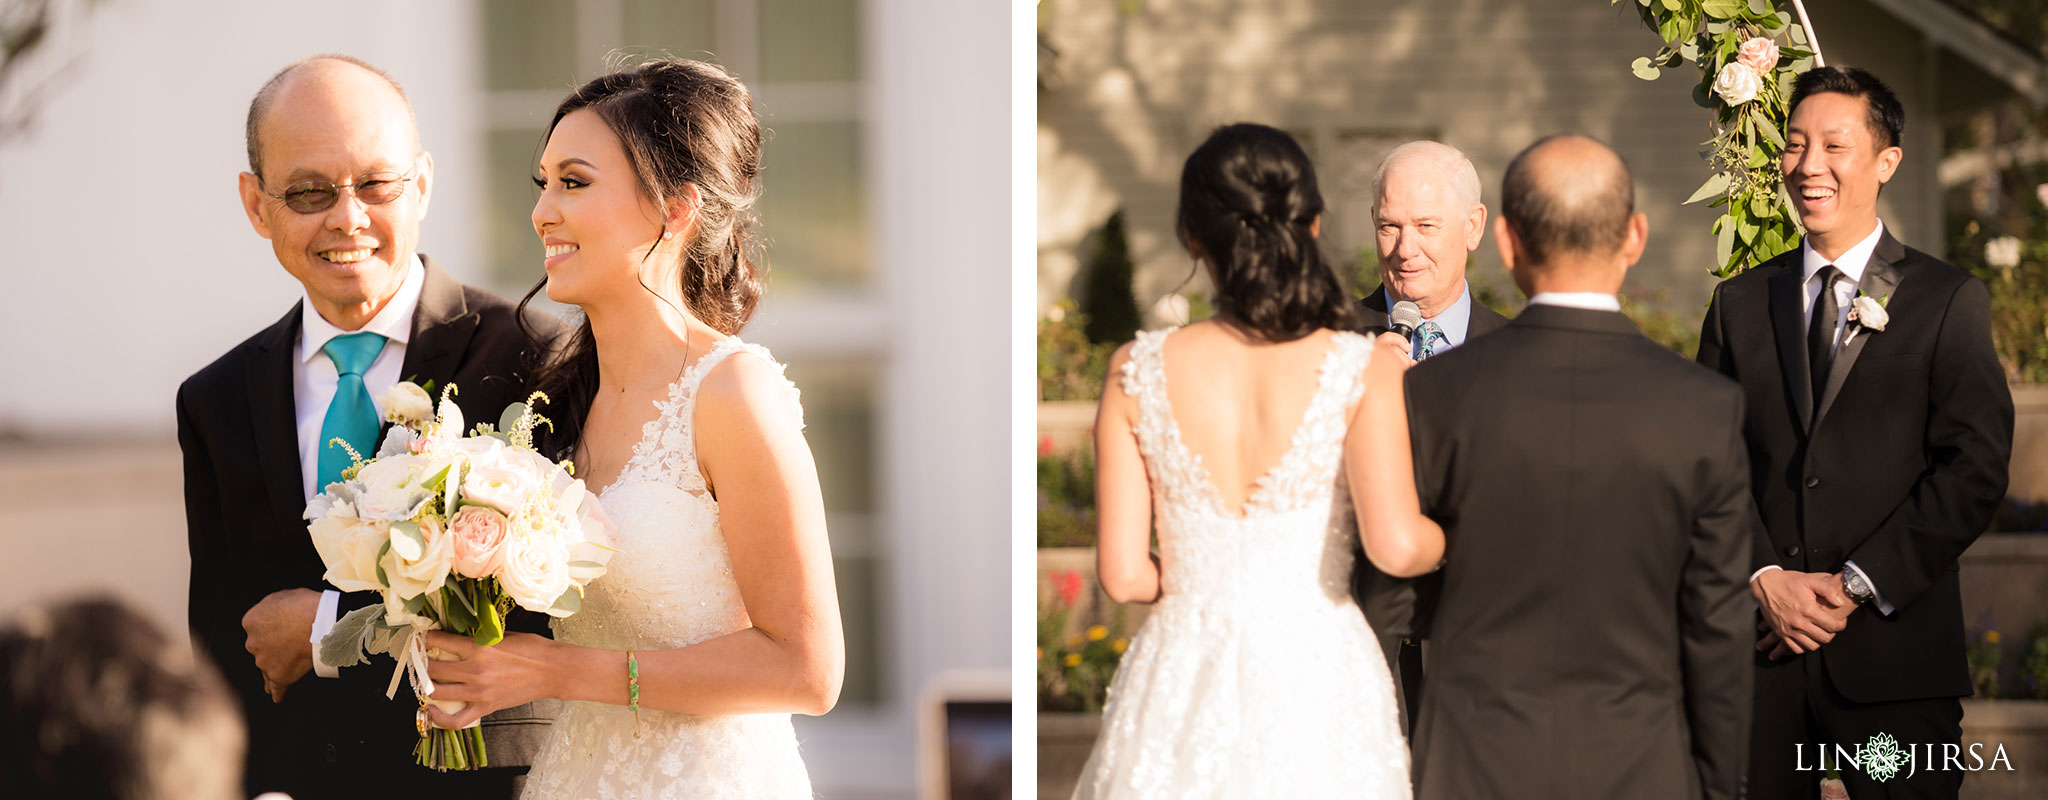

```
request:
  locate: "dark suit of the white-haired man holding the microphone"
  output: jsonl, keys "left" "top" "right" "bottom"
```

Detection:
{"left": 1352, "top": 286, "right": 1507, "bottom": 735}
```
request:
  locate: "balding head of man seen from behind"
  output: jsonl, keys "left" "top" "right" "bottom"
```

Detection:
{"left": 1501, "top": 133, "right": 1636, "bottom": 266}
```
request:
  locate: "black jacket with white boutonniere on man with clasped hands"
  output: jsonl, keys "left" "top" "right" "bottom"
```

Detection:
{"left": 1700, "top": 231, "right": 2013, "bottom": 702}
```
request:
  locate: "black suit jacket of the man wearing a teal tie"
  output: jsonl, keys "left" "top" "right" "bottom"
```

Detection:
{"left": 178, "top": 256, "right": 567, "bottom": 800}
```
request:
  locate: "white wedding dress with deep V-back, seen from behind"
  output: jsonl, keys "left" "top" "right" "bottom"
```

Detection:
{"left": 1075, "top": 331, "right": 1409, "bottom": 800}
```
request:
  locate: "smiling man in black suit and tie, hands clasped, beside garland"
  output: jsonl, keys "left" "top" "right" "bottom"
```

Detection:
{"left": 1700, "top": 68, "right": 2013, "bottom": 800}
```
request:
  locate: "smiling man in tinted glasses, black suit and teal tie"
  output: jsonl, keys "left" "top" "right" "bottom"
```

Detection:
{"left": 178, "top": 55, "right": 565, "bottom": 800}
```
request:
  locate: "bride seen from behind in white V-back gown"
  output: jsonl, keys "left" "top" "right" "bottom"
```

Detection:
{"left": 1075, "top": 125, "right": 1442, "bottom": 800}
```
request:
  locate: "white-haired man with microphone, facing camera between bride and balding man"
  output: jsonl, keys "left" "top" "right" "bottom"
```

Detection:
{"left": 1352, "top": 139, "right": 1507, "bottom": 730}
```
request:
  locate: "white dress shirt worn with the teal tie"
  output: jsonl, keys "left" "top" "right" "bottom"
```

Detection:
{"left": 291, "top": 256, "right": 426, "bottom": 677}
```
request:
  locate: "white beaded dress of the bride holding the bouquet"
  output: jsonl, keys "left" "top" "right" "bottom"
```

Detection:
{"left": 522, "top": 340, "right": 811, "bottom": 800}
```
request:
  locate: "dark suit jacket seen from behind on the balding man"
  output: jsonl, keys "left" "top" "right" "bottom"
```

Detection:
{"left": 1407, "top": 305, "right": 1755, "bottom": 800}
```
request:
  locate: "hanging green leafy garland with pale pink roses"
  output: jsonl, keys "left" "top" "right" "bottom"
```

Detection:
{"left": 1610, "top": 0, "right": 1815, "bottom": 278}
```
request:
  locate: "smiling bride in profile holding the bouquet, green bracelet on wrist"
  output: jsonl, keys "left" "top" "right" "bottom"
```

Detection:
{"left": 415, "top": 59, "right": 844, "bottom": 800}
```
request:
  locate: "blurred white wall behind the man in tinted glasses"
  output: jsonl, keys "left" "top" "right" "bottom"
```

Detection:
{"left": 0, "top": 0, "right": 481, "bottom": 438}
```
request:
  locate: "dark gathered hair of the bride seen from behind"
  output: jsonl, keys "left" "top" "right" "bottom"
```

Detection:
{"left": 1178, "top": 123, "right": 1356, "bottom": 342}
